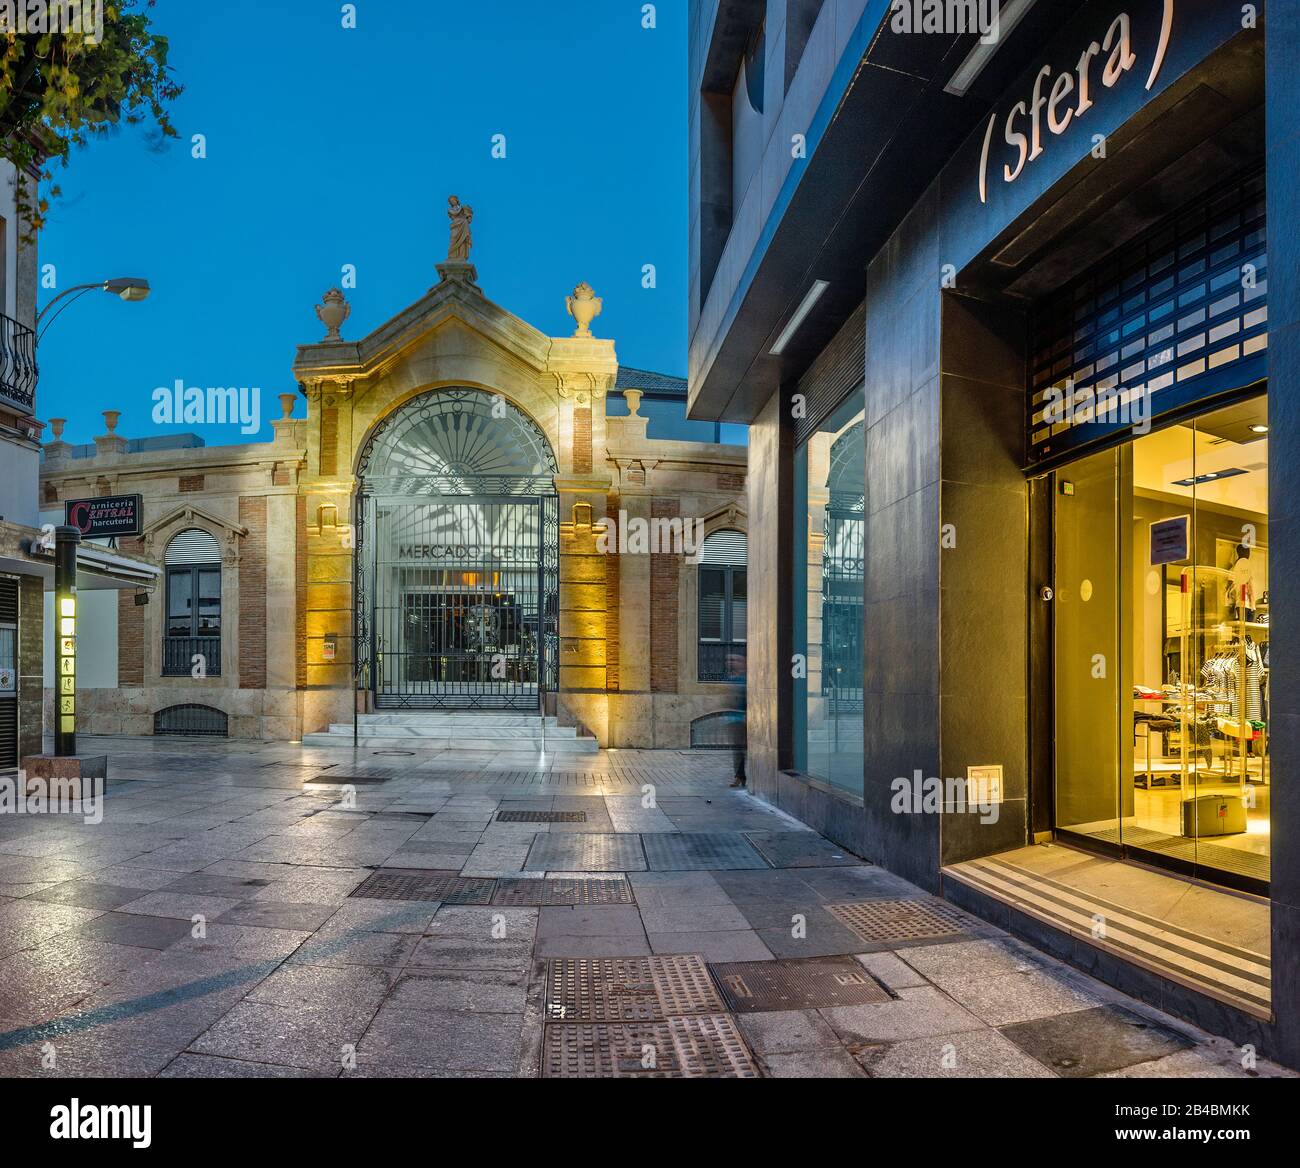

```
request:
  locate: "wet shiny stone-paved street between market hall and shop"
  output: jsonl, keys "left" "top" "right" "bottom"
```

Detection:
{"left": 0, "top": 739, "right": 1282, "bottom": 1078}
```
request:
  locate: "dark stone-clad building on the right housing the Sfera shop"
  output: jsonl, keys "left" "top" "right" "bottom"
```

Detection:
{"left": 689, "top": 0, "right": 1300, "bottom": 1065}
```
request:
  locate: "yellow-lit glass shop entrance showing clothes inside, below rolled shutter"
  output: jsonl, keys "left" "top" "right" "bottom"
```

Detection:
{"left": 1056, "top": 395, "right": 1274, "bottom": 891}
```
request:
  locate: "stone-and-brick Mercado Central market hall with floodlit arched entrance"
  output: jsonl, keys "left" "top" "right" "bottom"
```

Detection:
{"left": 40, "top": 261, "right": 746, "bottom": 752}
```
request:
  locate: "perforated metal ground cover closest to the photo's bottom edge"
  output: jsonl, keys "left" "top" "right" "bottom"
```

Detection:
{"left": 542, "top": 1013, "right": 759, "bottom": 1078}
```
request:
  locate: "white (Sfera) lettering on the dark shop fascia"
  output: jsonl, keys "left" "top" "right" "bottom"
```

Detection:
{"left": 979, "top": 0, "right": 1174, "bottom": 203}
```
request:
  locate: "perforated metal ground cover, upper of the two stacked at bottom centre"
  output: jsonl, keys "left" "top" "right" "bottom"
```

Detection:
{"left": 545, "top": 955, "right": 725, "bottom": 1022}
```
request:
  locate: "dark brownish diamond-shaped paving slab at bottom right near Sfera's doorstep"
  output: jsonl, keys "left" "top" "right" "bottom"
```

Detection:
{"left": 1001, "top": 1005, "right": 1192, "bottom": 1078}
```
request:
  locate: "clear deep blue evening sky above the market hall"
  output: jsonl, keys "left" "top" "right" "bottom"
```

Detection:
{"left": 38, "top": 0, "right": 686, "bottom": 445}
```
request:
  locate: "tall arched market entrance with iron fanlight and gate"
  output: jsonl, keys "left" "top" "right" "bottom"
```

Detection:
{"left": 355, "top": 389, "right": 559, "bottom": 710}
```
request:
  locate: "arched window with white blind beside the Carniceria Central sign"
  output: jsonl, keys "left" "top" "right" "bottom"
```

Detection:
{"left": 163, "top": 527, "right": 221, "bottom": 678}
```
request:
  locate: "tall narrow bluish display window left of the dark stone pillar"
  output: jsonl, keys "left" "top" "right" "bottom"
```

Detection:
{"left": 792, "top": 393, "right": 866, "bottom": 795}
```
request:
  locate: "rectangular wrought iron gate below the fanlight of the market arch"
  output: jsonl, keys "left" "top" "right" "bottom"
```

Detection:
{"left": 367, "top": 496, "right": 558, "bottom": 710}
